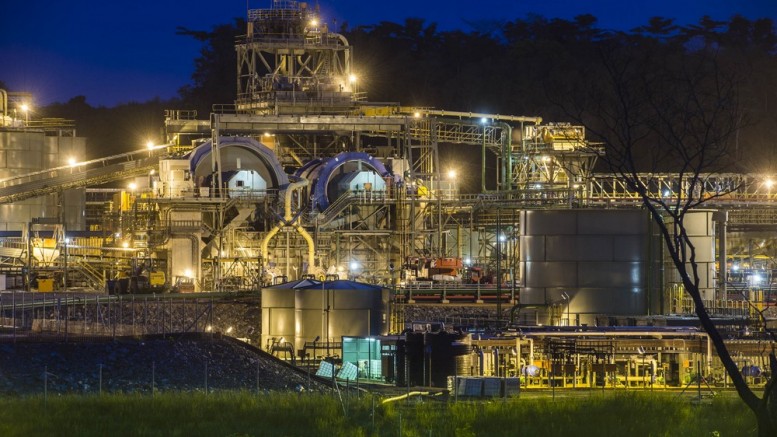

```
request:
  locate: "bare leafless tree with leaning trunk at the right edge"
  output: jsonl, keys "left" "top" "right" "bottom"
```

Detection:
{"left": 546, "top": 34, "right": 777, "bottom": 436}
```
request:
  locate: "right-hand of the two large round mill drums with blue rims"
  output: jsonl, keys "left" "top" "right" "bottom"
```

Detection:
{"left": 295, "top": 152, "right": 390, "bottom": 211}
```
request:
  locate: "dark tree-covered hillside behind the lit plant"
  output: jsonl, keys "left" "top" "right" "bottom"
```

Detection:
{"left": 7, "top": 15, "right": 777, "bottom": 173}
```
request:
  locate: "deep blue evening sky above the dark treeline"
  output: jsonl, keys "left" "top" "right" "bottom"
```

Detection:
{"left": 0, "top": 0, "right": 777, "bottom": 106}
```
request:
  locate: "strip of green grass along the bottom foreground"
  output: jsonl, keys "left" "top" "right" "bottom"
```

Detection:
{"left": 0, "top": 392, "right": 756, "bottom": 437}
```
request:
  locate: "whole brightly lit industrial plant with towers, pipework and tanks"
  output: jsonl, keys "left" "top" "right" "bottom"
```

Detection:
{"left": 0, "top": 0, "right": 777, "bottom": 393}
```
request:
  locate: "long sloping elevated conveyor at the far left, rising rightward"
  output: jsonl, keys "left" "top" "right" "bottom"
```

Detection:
{"left": 0, "top": 146, "right": 166, "bottom": 204}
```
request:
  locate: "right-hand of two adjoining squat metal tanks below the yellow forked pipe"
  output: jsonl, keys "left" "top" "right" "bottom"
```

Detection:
{"left": 294, "top": 280, "right": 389, "bottom": 350}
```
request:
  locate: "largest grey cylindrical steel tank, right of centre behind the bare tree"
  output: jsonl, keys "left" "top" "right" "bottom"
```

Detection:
{"left": 519, "top": 209, "right": 660, "bottom": 325}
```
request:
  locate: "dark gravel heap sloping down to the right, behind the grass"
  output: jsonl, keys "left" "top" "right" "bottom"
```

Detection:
{"left": 0, "top": 334, "right": 327, "bottom": 395}
